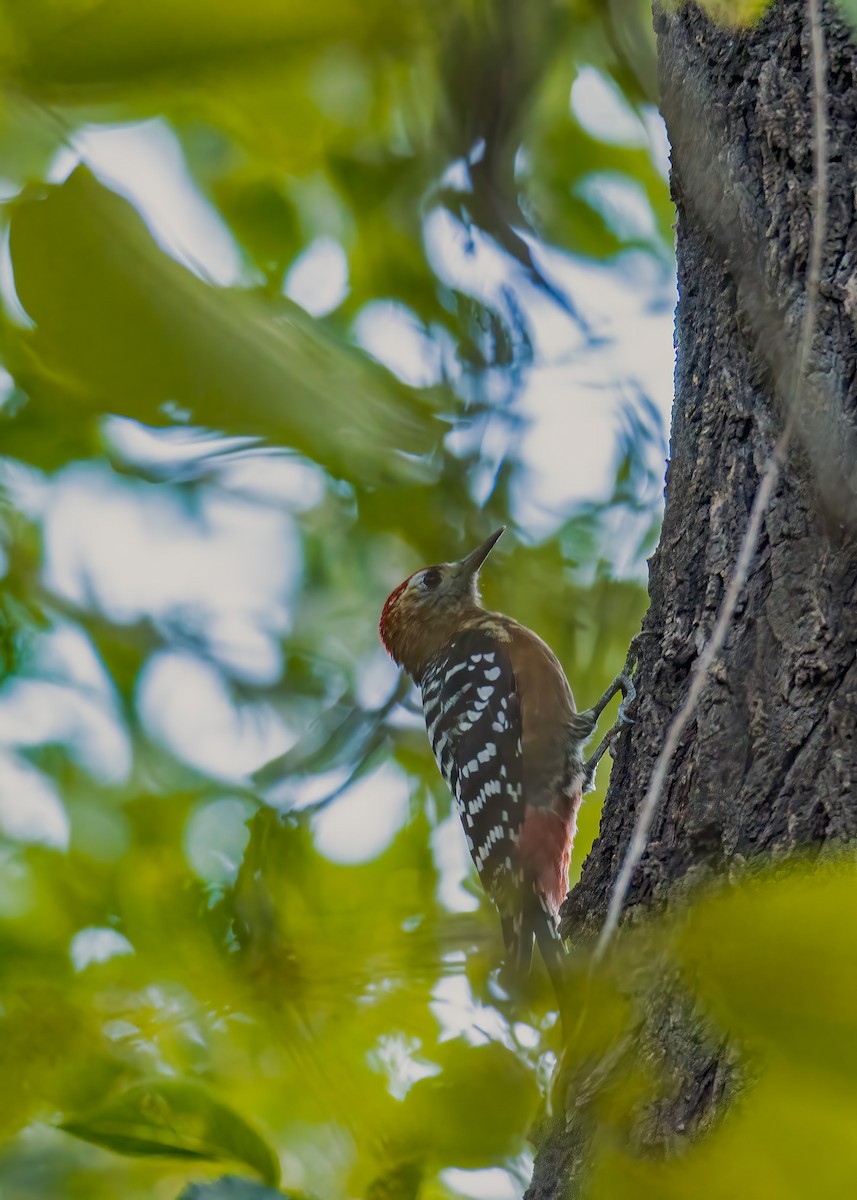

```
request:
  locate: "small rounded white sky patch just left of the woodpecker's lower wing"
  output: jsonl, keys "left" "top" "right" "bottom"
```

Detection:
{"left": 312, "top": 763, "right": 410, "bottom": 863}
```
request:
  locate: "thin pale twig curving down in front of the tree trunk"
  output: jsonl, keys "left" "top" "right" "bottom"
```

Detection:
{"left": 594, "top": 0, "right": 828, "bottom": 962}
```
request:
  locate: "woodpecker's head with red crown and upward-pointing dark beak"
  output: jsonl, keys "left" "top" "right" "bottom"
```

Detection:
{"left": 379, "top": 526, "right": 505, "bottom": 682}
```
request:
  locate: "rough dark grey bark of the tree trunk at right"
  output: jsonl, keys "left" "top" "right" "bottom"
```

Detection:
{"left": 527, "top": 0, "right": 857, "bottom": 1200}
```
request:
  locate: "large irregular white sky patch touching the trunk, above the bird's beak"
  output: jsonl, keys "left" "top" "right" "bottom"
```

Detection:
{"left": 420, "top": 224, "right": 676, "bottom": 538}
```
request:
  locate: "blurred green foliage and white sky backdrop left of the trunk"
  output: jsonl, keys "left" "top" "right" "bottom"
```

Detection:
{"left": 0, "top": 0, "right": 675, "bottom": 1200}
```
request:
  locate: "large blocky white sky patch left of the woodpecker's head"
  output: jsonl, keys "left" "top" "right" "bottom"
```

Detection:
{"left": 44, "top": 463, "right": 301, "bottom": 683}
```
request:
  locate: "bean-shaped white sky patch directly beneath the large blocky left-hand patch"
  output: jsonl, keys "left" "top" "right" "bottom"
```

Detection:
{"left": 137, "top": 652, "right": 290, "bottom": 784}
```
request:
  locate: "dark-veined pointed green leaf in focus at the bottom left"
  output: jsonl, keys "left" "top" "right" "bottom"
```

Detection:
{"left": 60, "top": 1080, "right": 280, "bottom": 1184}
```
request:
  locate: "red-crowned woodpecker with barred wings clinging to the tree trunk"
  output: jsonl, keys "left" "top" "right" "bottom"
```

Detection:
{"left": 380, "top": 526, "right": 635, "bottom": 1015}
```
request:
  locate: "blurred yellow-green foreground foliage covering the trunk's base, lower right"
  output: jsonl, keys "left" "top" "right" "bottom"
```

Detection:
{"left": 593, "top": 860, "right": 857, "bottom": 1200}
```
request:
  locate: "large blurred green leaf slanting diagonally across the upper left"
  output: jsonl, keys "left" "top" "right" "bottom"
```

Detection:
{"left": 10, "top": 168, "right": 443, "bottom": 486}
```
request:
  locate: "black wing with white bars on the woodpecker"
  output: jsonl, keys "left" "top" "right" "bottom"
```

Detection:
{"left": 422, "top": 630, "right": 525, "bottom": 913}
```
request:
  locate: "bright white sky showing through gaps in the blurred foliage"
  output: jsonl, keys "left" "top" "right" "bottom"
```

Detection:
{"left": 0, "top": 82, "right": 675, "bottom": 873}
